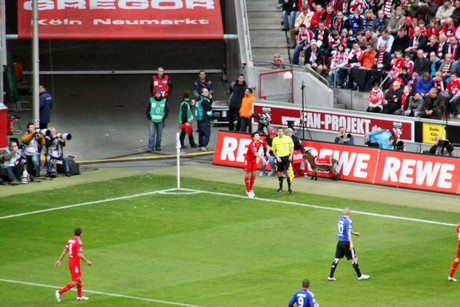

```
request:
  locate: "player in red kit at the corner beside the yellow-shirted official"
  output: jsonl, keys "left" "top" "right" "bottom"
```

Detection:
{"left": 244, "top": 132, "right": 270, "bottom": 198}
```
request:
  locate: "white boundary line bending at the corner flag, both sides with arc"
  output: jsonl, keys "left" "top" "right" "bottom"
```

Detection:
{"left": 0, "top": 188, "right": 457, "bottom": 227}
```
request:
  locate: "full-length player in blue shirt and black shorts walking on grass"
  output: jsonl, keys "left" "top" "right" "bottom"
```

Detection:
{"left": 327, "top": 208, "right": 370, "bottom": 281}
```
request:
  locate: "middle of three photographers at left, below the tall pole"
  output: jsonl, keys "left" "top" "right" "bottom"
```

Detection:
{"left": 22, "top": 123, "right": 46, "bottom": 177}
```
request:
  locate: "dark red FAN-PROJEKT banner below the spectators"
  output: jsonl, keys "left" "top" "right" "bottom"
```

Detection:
{"left": 253, "top": 102, "right": 414, "bottom": 142}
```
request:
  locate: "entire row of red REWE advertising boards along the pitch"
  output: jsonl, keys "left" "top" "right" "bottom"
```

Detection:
{"left": 212, "top": 131, "right": 460, "bottom": 194}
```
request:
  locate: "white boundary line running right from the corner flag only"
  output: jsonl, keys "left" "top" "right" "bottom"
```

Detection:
{"left": 187, "top": 189, "right": 457, "bottom": 227}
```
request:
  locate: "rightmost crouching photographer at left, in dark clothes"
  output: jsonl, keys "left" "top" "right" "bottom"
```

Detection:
{"left": 45, "top": 127, "right": 70, "bottom": 178}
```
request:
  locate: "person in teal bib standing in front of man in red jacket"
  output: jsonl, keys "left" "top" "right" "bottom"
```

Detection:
{"left": 145, "top": 89, "right": 169, "bottom": 153}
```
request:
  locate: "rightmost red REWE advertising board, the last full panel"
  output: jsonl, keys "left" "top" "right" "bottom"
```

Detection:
{"left": 375, "top": 150, "right": 460, "bottom": 194}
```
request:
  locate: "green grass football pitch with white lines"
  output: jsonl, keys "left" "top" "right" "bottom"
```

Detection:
{"left": 0, "top": 175, "right": 460, "bottom": 306}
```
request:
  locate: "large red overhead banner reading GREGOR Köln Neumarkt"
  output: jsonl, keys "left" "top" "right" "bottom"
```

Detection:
{"left": 18, "top": 0, "right": 223, "bottom": 40}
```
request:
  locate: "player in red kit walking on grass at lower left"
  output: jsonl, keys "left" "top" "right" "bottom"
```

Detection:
{"left": 55, "top": 228, "right": 92, "bottom": 303}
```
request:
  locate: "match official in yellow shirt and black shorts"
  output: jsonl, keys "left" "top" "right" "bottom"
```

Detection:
{"left": 272, "top": 128, "right": 294, "bottom": 194}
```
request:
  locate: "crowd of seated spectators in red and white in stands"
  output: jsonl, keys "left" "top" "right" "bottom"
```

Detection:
{"left": 278, "top": 0, "right": 460, "bottom": 119}
